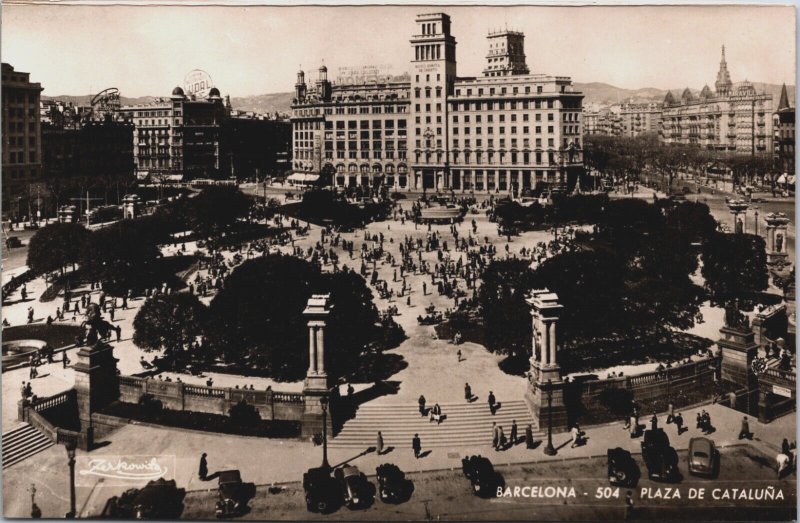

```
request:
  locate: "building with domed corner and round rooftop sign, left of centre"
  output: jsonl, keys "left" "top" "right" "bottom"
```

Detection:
{"left": 119, "top": 87, "right": 230, "bottom": 180}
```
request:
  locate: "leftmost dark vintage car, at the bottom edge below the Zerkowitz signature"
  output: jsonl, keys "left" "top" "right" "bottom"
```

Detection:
{"left": 101, "top": 478, "right": 184, "bottom": 519}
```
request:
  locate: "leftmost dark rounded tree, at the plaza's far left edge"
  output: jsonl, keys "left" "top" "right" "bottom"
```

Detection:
{"left": 26, "top": 223, "right": 89, "bottom": 274}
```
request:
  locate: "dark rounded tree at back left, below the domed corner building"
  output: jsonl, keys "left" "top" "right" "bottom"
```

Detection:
{"left": 189, "top": 185, "right": 251, "bottom": 236}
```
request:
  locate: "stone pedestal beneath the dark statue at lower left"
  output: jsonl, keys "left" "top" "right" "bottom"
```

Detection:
{"left": 74, "top": 341, "right": 119, "bottom": 450}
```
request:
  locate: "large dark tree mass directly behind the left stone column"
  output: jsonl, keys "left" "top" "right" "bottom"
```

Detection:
{"left": 207, "top": 255, "right": 394, "bottom": 380}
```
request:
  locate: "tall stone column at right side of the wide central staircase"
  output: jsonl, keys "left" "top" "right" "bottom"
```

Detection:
{"left": 525, "top": 289, "right": 567, "bottom": 430}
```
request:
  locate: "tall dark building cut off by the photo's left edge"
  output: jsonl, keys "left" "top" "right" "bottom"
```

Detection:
{"left": 1, "top": 63, "right": 43, "bottom": 217}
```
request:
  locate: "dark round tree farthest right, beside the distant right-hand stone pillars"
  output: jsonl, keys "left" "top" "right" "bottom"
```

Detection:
{"left": 702, "top": 233, "right": 769, "bottom": 302}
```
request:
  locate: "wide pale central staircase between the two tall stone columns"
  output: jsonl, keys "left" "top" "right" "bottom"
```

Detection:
{"left": 329, "top": 400, "right": 543, "bottom": 449}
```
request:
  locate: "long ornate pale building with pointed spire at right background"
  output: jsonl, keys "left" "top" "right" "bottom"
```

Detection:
{"left": 659, "top": 46, "right": 772, "bottom": 155}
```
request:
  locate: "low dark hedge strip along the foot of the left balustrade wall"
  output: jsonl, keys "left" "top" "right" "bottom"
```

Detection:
{"left": 100, "top": 401, "right": 300, "bottom": 438}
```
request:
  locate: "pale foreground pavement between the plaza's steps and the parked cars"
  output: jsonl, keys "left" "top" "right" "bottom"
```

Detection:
{"left": 3, "top": 405, "right": 796, "bottom": 517}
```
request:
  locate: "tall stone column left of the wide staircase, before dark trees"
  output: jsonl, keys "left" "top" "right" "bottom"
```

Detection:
{"left": 302, "top": 294, "right": 333, "bottom": 437}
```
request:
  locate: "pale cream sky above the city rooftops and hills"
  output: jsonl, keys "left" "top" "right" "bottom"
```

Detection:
{"left": 0, "top": 3, "right": 795, "bottom": 97}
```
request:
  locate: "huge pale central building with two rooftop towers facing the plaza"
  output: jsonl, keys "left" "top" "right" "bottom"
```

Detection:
{"left": 292, "top": 13, "right": 583, "bottom": 194}
